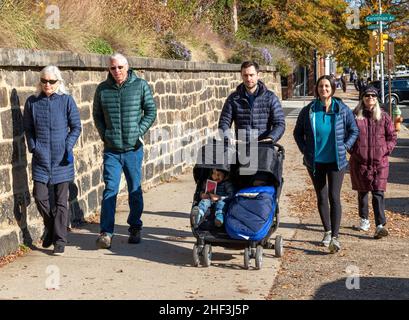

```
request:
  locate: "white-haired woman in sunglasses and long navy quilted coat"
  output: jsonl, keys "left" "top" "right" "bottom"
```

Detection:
{"left": 24, "top": 66, "right": 81, "bottom": 255}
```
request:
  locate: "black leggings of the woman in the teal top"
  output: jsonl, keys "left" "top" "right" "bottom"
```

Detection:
{"left": 308, "top": 163, "right": 345, "bottom": 237}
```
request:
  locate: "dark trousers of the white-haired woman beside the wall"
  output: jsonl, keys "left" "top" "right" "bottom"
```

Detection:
{"left": 33, "top": 181, "right": 69, "bottom": 246}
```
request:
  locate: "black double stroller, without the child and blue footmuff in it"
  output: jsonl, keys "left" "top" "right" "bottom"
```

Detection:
{"left": 190, "top": 140, "right": 284, "bottom": 269}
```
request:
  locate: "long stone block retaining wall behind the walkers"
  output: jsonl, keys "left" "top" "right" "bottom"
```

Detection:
{"left": 0, "top": 49, "right": 281, "bottom": 256}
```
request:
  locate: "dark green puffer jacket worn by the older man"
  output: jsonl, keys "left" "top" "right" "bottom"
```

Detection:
{"left": 93, "top": 70, "right": 156, "bottom": 152}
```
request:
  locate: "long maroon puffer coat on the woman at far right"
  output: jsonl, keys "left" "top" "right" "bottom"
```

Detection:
{"left": 349, "top": 111, "right": 396, "bottom": 191}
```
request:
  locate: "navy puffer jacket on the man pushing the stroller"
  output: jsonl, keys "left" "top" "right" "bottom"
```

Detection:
{"left": 219, "top": 81, "right": 285, "bottom": 142}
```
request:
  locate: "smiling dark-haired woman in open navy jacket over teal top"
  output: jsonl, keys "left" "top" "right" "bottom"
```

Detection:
{"left": 294, "top": 76, "right": 358, "bottom": 253}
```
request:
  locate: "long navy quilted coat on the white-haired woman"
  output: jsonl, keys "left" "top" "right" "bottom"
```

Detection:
{"left": 24, "top": 93, "right": 81, "bottom": 184}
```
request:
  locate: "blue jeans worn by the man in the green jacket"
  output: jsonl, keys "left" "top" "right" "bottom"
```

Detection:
{"left": 101, "top": 146, "right": 143, "bottom": 235}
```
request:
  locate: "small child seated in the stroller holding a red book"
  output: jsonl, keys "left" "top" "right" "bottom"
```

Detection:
{"left": 191, "top": 169, "right": 234, "bottom": 228}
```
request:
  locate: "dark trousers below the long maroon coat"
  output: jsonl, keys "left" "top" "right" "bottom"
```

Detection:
{"left": 358, "top": 190, "right": 386, "bottom": 226}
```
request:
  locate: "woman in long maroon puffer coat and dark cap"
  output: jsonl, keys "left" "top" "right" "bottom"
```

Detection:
{"left": 349, "top": 86, "right": 396, "bottom": 239}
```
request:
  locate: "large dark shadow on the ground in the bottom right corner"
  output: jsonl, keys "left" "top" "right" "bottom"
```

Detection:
{"left": 313, "top": 275, "right": 409, "bottom": 300}
